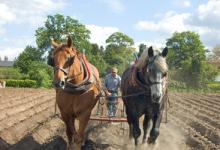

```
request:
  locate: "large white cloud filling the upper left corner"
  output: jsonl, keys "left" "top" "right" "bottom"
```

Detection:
{"left": 0, "top": 0, "right": 66, "bottom": 60}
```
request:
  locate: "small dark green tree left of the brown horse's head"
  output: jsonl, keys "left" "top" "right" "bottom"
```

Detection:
{"left": 14, "top": 46, "right": 43, "bottom": 74}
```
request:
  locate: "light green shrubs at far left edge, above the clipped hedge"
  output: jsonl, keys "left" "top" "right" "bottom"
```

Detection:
{"left": 0, "top": 68, "right": 26, "bottom": 79}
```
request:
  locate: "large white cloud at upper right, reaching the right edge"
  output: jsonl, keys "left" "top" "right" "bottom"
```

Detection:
{"left": 135, "top": 0, "right": 220, "bottom": 47}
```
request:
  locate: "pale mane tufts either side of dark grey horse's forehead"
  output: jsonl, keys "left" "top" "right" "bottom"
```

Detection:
{"left": 136, "top": 48, "right": 168, "bottom": 72}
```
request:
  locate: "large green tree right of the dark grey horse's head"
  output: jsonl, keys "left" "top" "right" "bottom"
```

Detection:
{"left": 166, "top": 31, "right": 217, "bottom": 87}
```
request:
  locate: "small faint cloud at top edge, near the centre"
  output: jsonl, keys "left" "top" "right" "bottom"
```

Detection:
{"left": 98, "top": 0, "right": 125, "bottom": 13}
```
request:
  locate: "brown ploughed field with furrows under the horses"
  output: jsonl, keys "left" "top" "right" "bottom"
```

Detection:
{"left": 0, "top": 88, "right": 220, "bottom": 150}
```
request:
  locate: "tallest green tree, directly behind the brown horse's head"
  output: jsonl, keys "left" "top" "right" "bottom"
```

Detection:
{"left": 36, "top": 14, "right": 90, "bottom": 53}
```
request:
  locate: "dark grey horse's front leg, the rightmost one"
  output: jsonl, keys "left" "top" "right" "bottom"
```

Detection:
{"left": 148, "top": 104, "right": 162, "bottom": 144}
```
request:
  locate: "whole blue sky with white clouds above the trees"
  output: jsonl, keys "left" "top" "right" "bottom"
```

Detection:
{"left": 0, "top": 0, "right": 220, "bottom": 60}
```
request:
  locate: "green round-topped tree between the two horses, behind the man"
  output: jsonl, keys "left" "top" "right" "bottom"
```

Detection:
{"left": 104, "top": 32, "right": 134, "bottom": 74}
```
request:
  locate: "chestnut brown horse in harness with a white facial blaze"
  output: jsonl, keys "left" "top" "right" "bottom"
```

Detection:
{"left": 48, "top": 37, "right": 101, "bottom": 150}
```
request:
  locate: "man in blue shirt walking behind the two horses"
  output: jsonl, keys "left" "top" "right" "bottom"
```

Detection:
{"left": 104, "top": 67, "right": 121, "bottom": 117}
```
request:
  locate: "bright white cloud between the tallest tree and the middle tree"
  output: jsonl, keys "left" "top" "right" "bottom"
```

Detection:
{"left": 86, "top": 25, "right": 119, "bottom": 46}
